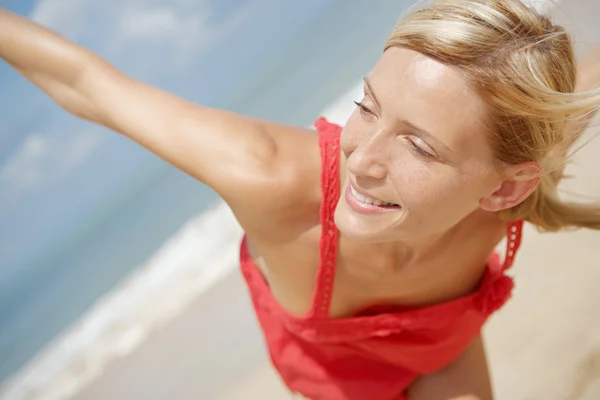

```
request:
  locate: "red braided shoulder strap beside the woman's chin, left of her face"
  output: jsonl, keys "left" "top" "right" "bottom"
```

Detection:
{"left": 311, "top": 117, "right": 342, "bottom": 318}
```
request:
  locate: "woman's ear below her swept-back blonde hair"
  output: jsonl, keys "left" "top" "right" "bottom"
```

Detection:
{"left": 479, "top": 161, "right": 542, "bottom": 212}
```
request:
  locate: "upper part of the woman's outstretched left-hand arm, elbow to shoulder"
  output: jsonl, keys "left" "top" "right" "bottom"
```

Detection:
{"left": 74, "top": 60, "right": 318, "bottom": 225}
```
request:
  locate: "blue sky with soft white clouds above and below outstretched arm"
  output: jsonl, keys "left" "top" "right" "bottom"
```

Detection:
{"left": 0, "top": 0, "right": 335, "bottom": 287}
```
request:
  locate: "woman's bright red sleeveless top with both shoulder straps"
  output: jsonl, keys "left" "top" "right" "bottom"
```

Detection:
{"left": 240, "top": 118, "right": 523, "bottom": 400}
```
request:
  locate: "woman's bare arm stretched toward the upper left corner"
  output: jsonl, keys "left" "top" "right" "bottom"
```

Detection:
{"left": 0, "top": 9, "right": 306, "bottom": 228}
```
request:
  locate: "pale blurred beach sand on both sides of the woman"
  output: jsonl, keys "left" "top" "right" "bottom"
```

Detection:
{"left": 8, "top": 0, "right": 600, "bottom": 400}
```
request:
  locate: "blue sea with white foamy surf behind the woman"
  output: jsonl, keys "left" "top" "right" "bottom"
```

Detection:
{"left": 0, "top": 0, "right": 412, "bottom": 399}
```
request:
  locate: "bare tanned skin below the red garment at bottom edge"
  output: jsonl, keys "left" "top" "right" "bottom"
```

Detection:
{"left": 408, "top": 336, "right": 493, "bottom": 400}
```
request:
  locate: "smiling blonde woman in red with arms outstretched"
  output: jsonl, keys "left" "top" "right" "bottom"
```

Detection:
{"left": 0, "top": 0, "right": 600, "bottom": 400}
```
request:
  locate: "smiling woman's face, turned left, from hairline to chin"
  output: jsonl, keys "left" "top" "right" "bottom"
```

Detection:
{"left": 335, "top": 47, "right": 502, "bottom": 242}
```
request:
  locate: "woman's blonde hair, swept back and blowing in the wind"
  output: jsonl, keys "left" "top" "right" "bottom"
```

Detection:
{"left": 385, "top": 0, "right": 600, "bottom": 231}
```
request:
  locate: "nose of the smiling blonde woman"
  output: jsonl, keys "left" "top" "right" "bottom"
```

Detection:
{"left": 346, "top": 130, "right": 388, "bottom": 179}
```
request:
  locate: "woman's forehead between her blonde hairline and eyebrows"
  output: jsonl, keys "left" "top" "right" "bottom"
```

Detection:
{"left": 369, "top": 47, "right": 486, "bottom": 155}
